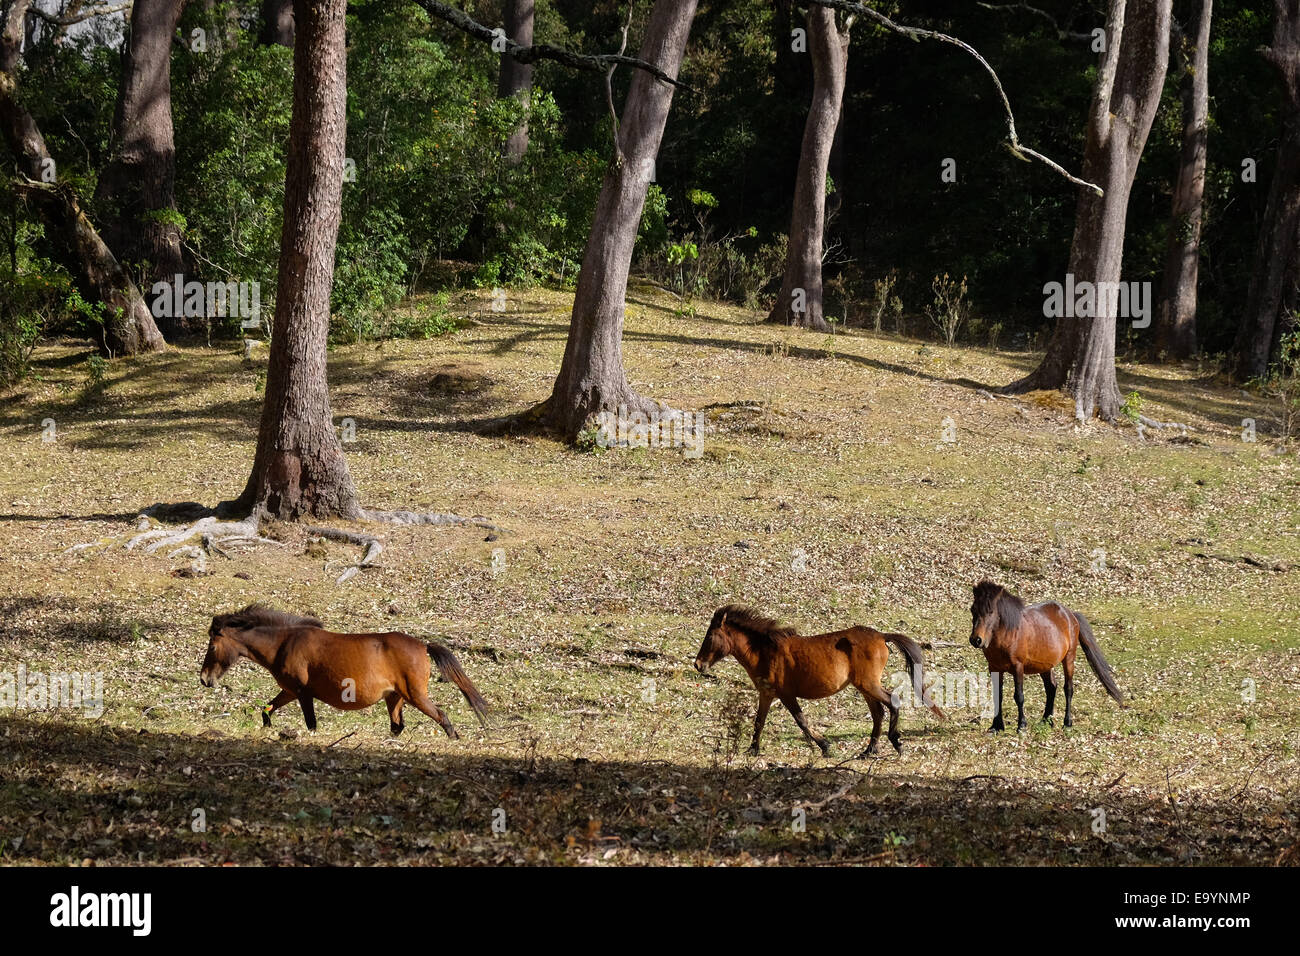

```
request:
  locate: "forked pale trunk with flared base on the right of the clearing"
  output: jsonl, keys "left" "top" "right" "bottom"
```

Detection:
{"left": 1006, "top": 0, "right": 1173, "bottom": 421}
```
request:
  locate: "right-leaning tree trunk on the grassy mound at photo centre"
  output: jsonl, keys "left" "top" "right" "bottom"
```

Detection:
{"left": 538, "top": 0, "right": 696, "bottom": 440}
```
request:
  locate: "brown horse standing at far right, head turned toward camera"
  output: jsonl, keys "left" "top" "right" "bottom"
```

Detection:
{"left": 971, "top": 580, "right": 1125, "bottom": 734}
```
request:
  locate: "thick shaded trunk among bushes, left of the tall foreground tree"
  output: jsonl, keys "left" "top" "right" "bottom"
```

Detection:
{"left": 95, "top": 0, "right": 194, "bottom": 334}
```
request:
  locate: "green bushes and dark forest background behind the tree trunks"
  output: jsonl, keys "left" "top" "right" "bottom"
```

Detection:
{"left": 0, "top": 0, "right": 1282, "bottom": 381}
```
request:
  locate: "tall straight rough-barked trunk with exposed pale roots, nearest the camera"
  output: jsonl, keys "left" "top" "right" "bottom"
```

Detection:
{"left": 224, "top": 0, "right": 360, "bottom": 519}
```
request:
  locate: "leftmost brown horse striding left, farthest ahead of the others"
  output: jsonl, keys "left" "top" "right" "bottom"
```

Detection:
{"left": 199, "top": 604, "right": 488, "bottom": 740}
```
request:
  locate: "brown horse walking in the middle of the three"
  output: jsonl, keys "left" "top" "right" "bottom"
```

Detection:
{"left": 696, "top": 605, "right": 944, "bottom": 760}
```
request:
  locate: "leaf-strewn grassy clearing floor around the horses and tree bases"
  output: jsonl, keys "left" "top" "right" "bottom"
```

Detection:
{"left": 0, "top": 284, "right": 1300, "bottom": 865}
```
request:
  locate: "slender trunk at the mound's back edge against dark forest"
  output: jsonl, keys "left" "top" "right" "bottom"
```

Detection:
{"left": 767, "top": 7, "right": 849, "bottom": 330}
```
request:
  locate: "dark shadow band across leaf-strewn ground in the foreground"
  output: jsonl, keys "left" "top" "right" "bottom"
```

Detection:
{"left": 0, "top": 714, "right": 1296, "bottom": 865}
